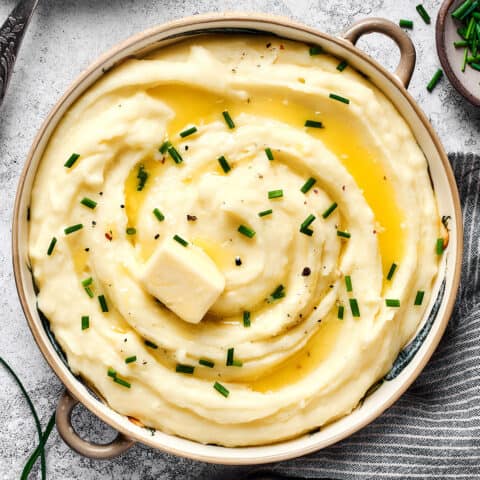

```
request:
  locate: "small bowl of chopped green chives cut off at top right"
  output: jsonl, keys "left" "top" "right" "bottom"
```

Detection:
{"left": 436, "top": 0, "right": 480, "bottom": 107}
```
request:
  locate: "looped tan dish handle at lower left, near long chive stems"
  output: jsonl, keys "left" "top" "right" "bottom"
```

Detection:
{"left": 55, "top": 390, "right": 135, "bottom": 460}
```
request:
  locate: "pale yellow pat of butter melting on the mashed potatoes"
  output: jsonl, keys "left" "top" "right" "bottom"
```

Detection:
{"left": 141, "top": 239, "right": 225, "bottom": 323}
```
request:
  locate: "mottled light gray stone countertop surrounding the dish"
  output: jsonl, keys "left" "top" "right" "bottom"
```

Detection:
{"left": 0, "top": 0, "right": 480, "bottom": 480}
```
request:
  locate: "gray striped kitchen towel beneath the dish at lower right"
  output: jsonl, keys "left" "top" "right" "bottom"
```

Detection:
{"left": 210, "top": 153, "right": 480, "bottom": 480}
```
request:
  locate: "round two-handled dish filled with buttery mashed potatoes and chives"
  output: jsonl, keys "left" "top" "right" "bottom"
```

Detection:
{"left": 13, "top": 14, "right": 462, "bottom": 464}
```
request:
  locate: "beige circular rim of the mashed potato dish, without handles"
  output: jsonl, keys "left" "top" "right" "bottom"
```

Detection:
{"left": 12, "top": 12, "right": 463, "bottom": 465}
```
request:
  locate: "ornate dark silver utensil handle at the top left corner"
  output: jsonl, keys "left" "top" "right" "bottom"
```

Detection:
{"left": 0, "top": 0, "right": 38, "bottom": 104}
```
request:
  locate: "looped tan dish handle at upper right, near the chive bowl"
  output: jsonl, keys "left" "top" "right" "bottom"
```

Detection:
{"left": 342, "top": 18, "right": 417, "bottom": 88}
